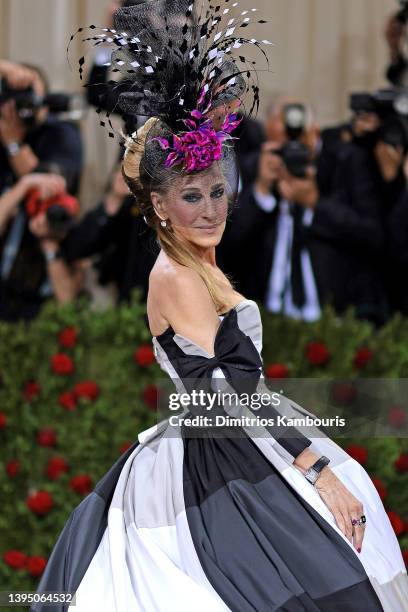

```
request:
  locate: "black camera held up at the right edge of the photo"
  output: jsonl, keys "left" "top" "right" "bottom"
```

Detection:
{"left": 350, "top": 88, "right": 408, "bottom": 153}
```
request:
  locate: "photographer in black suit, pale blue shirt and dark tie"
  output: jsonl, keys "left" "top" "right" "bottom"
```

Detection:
{"left": 219, "top": 98, "right": 326, "bottom": 321}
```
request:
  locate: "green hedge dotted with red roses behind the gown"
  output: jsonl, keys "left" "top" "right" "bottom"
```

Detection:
{"left": 0, "top": 296, "right": 408, "bottom": 596}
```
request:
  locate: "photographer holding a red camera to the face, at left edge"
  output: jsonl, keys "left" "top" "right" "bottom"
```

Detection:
{"left": 0, "top": 174, "right": 82, "bottom": 321}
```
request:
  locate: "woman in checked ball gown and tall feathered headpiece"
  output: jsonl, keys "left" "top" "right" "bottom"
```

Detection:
{"left": 32, "top": 2, "right": 408, "bottom": 612}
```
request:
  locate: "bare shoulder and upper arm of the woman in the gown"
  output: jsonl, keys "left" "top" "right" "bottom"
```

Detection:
{"left": 147, "top": 255, "right": 220, "bottom": 354}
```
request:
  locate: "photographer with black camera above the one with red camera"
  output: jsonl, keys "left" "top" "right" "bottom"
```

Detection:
{"left": 0, "top": 60, "right": 82, "bottom": 193}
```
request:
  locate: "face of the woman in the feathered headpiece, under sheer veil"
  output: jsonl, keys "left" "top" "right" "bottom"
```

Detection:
{"left": 151, "top": 163, "right": 228, "bottom": 248}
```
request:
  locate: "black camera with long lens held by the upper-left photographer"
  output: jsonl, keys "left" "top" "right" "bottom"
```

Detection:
{"left": 0, "top": 78, "right": 85, "bottom": 125}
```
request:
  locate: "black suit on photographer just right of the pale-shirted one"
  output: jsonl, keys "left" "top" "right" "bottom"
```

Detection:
{"left": 311, "top": 143, "right": 390, "bottom": 325}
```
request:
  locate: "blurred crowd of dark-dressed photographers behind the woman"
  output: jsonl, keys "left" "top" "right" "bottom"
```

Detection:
{"left": 0, "top": 0, "right": 408, "bottom": 326}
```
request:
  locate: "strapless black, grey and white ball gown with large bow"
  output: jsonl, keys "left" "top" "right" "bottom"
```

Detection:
{"left": 32, "top": 300, "right": 408, "bottom": 612}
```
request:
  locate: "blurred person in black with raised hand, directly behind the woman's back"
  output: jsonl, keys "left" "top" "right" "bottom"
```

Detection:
{"left": 61, "top": 164, "right": 159, "bottom": 302}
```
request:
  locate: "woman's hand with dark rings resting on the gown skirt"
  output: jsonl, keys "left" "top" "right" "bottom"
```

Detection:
{"left": 314, "top": 466, "right": 365, "bottom": 552}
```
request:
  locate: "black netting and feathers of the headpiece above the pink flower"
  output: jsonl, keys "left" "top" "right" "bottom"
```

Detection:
{"left": 67, "top": 0, "right": 271, "bottom": 147}
